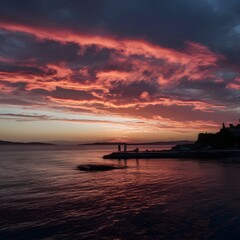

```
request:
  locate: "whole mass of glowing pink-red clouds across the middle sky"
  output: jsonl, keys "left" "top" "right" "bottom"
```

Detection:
{"left": 0, "top": 20, "right": 237, "bottom": 137}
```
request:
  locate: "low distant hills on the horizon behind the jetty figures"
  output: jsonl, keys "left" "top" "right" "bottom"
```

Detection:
{"left": 79, "top": 140, "right": 194, "bottom": 146}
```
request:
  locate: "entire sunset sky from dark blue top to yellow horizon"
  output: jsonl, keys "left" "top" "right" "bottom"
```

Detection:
{"left": 0, "top": 0, "right": 240, "bottom": 142}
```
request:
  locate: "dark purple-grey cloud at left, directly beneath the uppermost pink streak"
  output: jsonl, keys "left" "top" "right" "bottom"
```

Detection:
{"left": 0, "top": 30, "right": 114, "bottom": 74}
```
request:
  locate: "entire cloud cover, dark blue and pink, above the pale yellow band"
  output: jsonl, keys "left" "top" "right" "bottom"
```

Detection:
{"left": 0, "top": 0, "right": 240, "bottom": 128}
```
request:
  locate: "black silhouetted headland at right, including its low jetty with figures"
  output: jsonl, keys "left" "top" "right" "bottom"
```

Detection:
{"left": 103, "top": 123, "right": 240, "bottom": 159}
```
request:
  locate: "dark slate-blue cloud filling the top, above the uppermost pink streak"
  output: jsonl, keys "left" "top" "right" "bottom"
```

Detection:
{"left": 0, "top": 0, "right": 240, "bottom": 58}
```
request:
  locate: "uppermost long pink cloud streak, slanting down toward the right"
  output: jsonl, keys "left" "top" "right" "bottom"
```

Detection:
{"left": 0, "top": 23, "right": 222, "bottom": 66}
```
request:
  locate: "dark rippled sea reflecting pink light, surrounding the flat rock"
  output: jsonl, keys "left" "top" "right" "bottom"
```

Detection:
{"left": 0, "top": 146, "right": 240, "bottom": 240}
